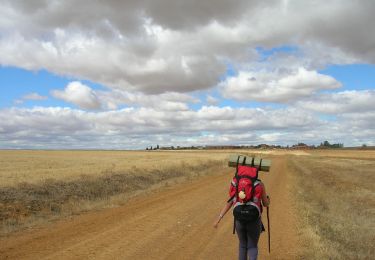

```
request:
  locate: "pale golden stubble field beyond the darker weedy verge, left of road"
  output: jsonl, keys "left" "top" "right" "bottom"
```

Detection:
{"left": 0, "top": 150, "right": 232, "bottom": 187}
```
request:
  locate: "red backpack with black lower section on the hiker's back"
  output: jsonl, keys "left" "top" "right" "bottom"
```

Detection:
{"left": 228, "top": 157, "right": 262, "bottom": 228}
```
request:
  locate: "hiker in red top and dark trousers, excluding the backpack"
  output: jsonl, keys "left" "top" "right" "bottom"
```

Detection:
{"left": 214, "top": 169, "right": 270, "bottom": 260}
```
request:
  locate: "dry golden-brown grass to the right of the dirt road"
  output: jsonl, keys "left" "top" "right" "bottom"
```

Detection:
{"left": 289, "top": 151, "right": 375, "bottom": 259}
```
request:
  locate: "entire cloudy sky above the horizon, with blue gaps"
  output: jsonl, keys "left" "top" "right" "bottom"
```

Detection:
{"left": 0, "top": 0, "right": 375, "bottom": 149}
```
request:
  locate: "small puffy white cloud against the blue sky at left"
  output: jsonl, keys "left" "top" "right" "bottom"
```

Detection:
{"left": 51, "top": 81, "right": 101, "bottom": 109}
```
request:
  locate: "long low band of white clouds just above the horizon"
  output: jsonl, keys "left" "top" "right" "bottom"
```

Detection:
{"left": 0, "top": 103, "right": 375, "bottom": 149}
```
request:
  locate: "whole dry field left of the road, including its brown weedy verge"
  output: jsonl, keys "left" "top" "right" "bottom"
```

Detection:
{"left": 0, "top": 151, "right": 232, "bottom": 235}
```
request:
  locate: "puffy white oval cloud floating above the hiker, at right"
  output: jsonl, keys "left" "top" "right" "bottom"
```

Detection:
{"left": 220, "top": 68, "right": 341, "bottom": 103}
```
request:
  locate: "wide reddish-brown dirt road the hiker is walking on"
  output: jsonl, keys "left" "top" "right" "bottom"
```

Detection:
{"left": 0, "top": 157, "right": 298, "bottom": 259}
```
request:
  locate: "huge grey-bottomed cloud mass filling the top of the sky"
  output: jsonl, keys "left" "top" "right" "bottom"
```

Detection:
{"left": 0, "top": 0, "right": 375, "bottom": 94}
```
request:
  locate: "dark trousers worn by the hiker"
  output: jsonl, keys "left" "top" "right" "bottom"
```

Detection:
{"left": 236, "top": 219, "right": 262, "bottom": 260}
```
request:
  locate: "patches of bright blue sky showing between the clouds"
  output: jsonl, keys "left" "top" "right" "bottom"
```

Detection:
{"left": 0, "top": 63, "right": 375, "bottom": 109}
